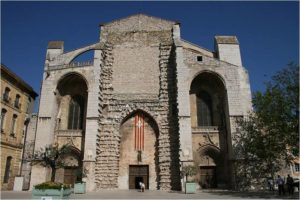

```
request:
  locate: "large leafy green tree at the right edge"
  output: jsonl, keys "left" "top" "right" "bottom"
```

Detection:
{"left": 233, "top": 63, "right": 299, "bottom": 191}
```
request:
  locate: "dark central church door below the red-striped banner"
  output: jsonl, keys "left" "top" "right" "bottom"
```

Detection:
{"left": 129, "top": 165, "right": 149, "bottom": 189}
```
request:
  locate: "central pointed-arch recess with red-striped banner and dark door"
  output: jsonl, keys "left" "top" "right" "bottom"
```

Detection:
{"left": 118, "top": 110, "right": 159, "bottom": 190}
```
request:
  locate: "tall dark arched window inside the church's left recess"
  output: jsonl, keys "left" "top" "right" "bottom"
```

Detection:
{"left": 68, "top": 96, "right": 84, "bottom": 130}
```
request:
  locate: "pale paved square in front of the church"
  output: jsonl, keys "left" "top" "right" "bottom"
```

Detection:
{"left": 1, "top": 190, "right": 299, "bottom": 199}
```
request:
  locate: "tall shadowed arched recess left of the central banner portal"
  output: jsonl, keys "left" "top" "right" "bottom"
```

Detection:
{"left": 55, "top": 73, "right": 88, "bottom": 185}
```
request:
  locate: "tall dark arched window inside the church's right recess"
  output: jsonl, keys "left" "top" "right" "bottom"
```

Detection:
{"left": 197, "top": 91, "right": 213, "bottom": 126}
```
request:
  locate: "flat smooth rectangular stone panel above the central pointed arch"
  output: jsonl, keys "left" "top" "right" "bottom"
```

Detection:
{"left": 112, "top": 44, "right": 159, "bottom": 95}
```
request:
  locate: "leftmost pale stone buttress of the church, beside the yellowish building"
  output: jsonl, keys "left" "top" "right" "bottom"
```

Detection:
{"left": 30, "top": 41, "right": 63, "bottom": 189}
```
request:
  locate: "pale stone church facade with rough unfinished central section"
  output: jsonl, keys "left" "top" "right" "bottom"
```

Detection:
{"left": 31, "top": 14, "right": 251, "bottom": 191}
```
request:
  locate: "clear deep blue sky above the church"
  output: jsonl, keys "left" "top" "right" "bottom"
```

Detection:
{"left": 1, "top": 1, "right": 299, "bottom": 110}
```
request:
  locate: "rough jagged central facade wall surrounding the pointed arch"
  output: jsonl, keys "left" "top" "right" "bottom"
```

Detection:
{"left": 95, "top": 16, "right": 180, "bottom": 190}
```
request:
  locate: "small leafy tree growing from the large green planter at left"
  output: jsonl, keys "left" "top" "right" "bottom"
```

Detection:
{"left": 31, "top": 145, "right": 71, "bottom": 182}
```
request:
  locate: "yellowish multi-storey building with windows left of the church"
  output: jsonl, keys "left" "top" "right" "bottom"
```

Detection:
{"left": 0, "top": 64, "right": 38, "bottom": 190}
